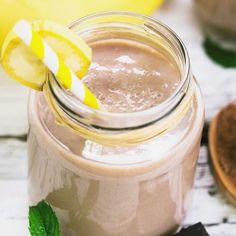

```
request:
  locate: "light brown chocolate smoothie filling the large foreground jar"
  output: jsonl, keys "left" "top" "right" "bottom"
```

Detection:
{"left": 28, "top": 14, "right": 203, "bottom": 236}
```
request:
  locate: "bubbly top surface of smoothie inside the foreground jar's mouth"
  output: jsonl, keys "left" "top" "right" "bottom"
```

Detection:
{"left": 83, "top": 39, "right": 180, "bottom": 112}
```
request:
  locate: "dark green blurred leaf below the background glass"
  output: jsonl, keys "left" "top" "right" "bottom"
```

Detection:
{"left": 203, "top": 36, "right": 236, "bottom": 68}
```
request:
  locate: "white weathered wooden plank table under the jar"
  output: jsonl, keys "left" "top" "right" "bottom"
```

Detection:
{"left": 0, "top": 0, "right": 236, "bottom": 236}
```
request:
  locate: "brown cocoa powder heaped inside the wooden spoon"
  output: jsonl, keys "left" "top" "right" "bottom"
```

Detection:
{"left": 216, "top": 101, "right": 236, "bottom": 186}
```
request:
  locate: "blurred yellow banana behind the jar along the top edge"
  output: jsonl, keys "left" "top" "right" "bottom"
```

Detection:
{"left": 0, "top": 0, "right": 164, "bottom": 48}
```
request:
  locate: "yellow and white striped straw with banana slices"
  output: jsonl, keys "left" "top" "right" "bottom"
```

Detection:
{"left": 14, "top": 20, "right": 99, "bottom": 109}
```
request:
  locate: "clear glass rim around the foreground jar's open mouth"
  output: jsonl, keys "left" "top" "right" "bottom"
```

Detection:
{"left": 48, "top": 11, "right": 191, "bottom": 130}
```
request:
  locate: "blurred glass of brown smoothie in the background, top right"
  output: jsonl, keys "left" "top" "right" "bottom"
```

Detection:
{"left": 195, "top": 0, "right": 236, "bottom": 49}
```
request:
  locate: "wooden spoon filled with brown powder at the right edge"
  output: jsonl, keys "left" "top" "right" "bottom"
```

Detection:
{"left": 209, "top": 101, "right": 236, "bottom": 206}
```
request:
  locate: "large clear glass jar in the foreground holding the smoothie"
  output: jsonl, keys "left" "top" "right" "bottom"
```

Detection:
{"left": 28, "top": 12, "right": 204, "bottom": 236}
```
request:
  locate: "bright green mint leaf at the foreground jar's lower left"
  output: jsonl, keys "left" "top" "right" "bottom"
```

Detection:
{"left": 29, "top": 201, "right": 60, "bottom": 236}
